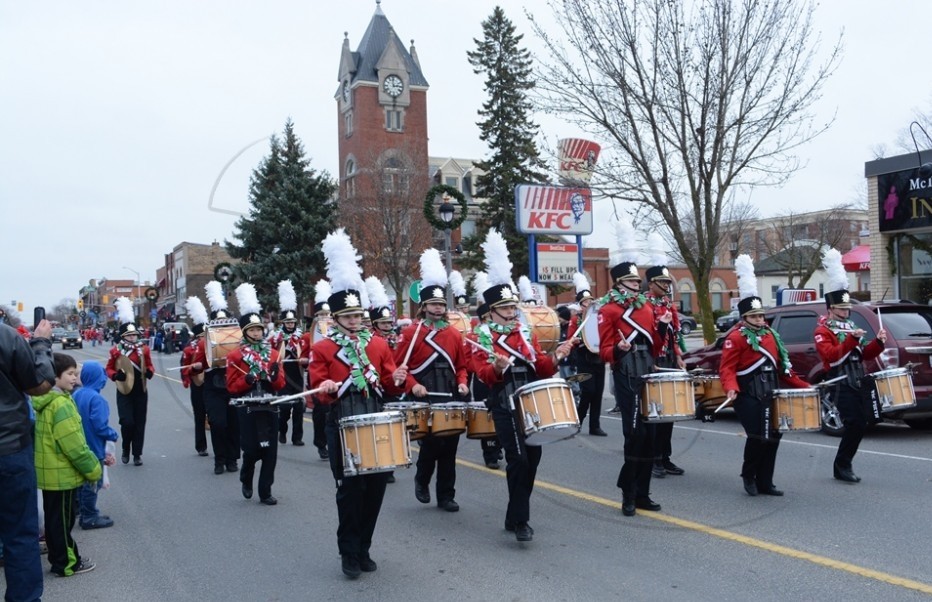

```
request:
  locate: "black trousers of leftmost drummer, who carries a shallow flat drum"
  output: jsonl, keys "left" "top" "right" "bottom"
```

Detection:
{"left": 237, "top": 406, "right": 278, "bottom": 500}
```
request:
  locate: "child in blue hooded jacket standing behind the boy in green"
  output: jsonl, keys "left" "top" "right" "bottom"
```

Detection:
{"left": 73, "top": 362, "right": 119, "bottom": 529}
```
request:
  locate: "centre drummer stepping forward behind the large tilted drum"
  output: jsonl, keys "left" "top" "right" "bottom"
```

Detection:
{"left": 471, "top": 230, "right": 573, "bottom": 541}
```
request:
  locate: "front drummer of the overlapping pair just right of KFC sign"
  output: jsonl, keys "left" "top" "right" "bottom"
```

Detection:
{"left": 599, "top": 221, "right": 673, "bottom": 516}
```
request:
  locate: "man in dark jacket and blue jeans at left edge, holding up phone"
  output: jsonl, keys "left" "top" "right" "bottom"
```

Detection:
{"left": 0, "top": 320, "right": 55, "bottom": 600}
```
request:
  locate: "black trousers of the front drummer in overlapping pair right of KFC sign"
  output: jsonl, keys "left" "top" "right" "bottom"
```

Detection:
{"left": 612, "top": 369, "right": 656, "bottom": 499}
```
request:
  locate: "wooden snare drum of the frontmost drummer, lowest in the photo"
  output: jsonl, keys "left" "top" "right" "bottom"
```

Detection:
{"left": 339, "top": 412, "right": 411, "bottom": 477}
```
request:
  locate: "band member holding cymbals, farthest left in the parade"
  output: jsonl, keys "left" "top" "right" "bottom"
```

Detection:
{"left": 107, "top": 297, "right": 155, "bottom": 466}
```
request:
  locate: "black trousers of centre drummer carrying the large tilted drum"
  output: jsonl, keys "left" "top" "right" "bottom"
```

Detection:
{"left": 492, "top": 406, "right": 542, "bottom": 525}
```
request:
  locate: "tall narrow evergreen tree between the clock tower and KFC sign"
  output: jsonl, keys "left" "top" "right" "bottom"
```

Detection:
{"left": 461, "top": 7, "right": 547, "bottom": 279}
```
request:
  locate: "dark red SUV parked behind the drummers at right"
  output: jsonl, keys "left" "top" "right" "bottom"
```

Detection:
{"left": 684, "top": 301, "right": 932, "bottom": 435}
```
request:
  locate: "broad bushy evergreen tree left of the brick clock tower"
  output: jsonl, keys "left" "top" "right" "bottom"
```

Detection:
{"left": 225, "top": 119, "right": 336, "bottom": 311}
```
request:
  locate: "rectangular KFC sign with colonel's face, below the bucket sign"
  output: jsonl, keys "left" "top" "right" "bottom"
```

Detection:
{"left": 515, "top": 184, "right": 592, "bottom": 235}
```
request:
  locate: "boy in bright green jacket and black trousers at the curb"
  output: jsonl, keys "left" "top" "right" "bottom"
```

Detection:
{"left": 32, "top": 353, "right": 102, "bottom": 577}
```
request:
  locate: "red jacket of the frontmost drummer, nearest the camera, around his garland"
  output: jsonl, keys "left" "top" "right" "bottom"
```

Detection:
{"left": 308, "top": 336, "right": 411, "bottom": 405}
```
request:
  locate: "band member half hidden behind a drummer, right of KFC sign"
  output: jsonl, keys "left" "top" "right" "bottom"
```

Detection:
{"left": 646, "top": 232, "right": 686, "bottom": 479}
